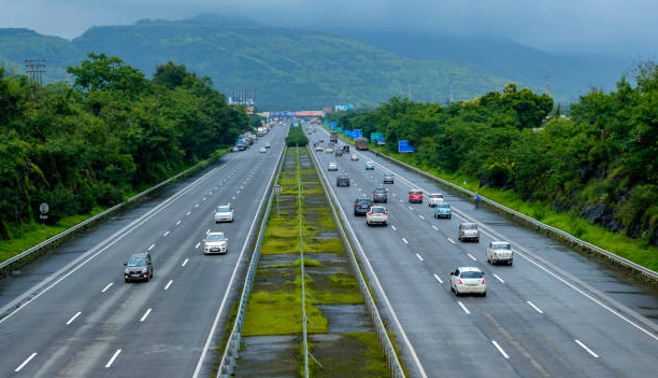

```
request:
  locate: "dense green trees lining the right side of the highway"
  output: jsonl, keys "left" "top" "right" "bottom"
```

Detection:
{"left": 332, "top": 62, "right": 658, "bottom": 245}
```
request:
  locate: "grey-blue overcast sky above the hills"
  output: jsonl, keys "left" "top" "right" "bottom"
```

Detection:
{"left": 0, "top": 0, "right": 658, "bottom": 60}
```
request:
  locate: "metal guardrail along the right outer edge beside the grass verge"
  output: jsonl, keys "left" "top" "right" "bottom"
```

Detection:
{"left": 377, "top": 152, "right": 658, "bottom": 281}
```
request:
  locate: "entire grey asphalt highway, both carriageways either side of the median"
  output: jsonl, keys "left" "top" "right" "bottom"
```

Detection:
{"left": 0, "top": 122, "right": 658, "bottom": 377}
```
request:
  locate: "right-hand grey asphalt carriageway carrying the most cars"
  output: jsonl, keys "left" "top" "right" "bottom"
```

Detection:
{"left": 311, "top": 127, "right": 658, "bottom": 377}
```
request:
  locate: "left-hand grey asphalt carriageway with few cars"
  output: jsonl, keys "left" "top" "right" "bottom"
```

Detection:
{"left": 0, "top": 127, "right": 287, "bottom": 377}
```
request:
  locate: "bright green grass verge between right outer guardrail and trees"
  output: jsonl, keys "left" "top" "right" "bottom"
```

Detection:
{"left": 390, "top": 149, "right": 658, "bottom": 271}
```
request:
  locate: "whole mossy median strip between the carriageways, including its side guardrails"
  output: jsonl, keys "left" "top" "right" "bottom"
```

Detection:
{"left": 218, "top": 148, "right": 404, "bottom": 377}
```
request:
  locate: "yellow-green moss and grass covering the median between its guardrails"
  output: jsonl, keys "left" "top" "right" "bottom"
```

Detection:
{"left": 236, "top": 147, "right": 390, "bottom": 377}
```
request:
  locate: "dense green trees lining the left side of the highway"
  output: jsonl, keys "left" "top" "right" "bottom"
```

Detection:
{"left": 0, "top": 53, "right": 251, "bottom": 240}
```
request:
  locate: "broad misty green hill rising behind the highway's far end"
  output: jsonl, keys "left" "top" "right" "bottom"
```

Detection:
{"left": 0, "top": 14, "right": 621, "bottom": 110}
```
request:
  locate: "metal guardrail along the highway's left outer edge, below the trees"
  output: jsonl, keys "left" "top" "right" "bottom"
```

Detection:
{"left": 0, "top": 165, "right": 200, "bottom": 277}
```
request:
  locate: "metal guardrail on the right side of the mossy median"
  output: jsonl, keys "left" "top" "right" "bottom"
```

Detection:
{"left": 310, "top": 146, "right": 405, "bottom": 378}
